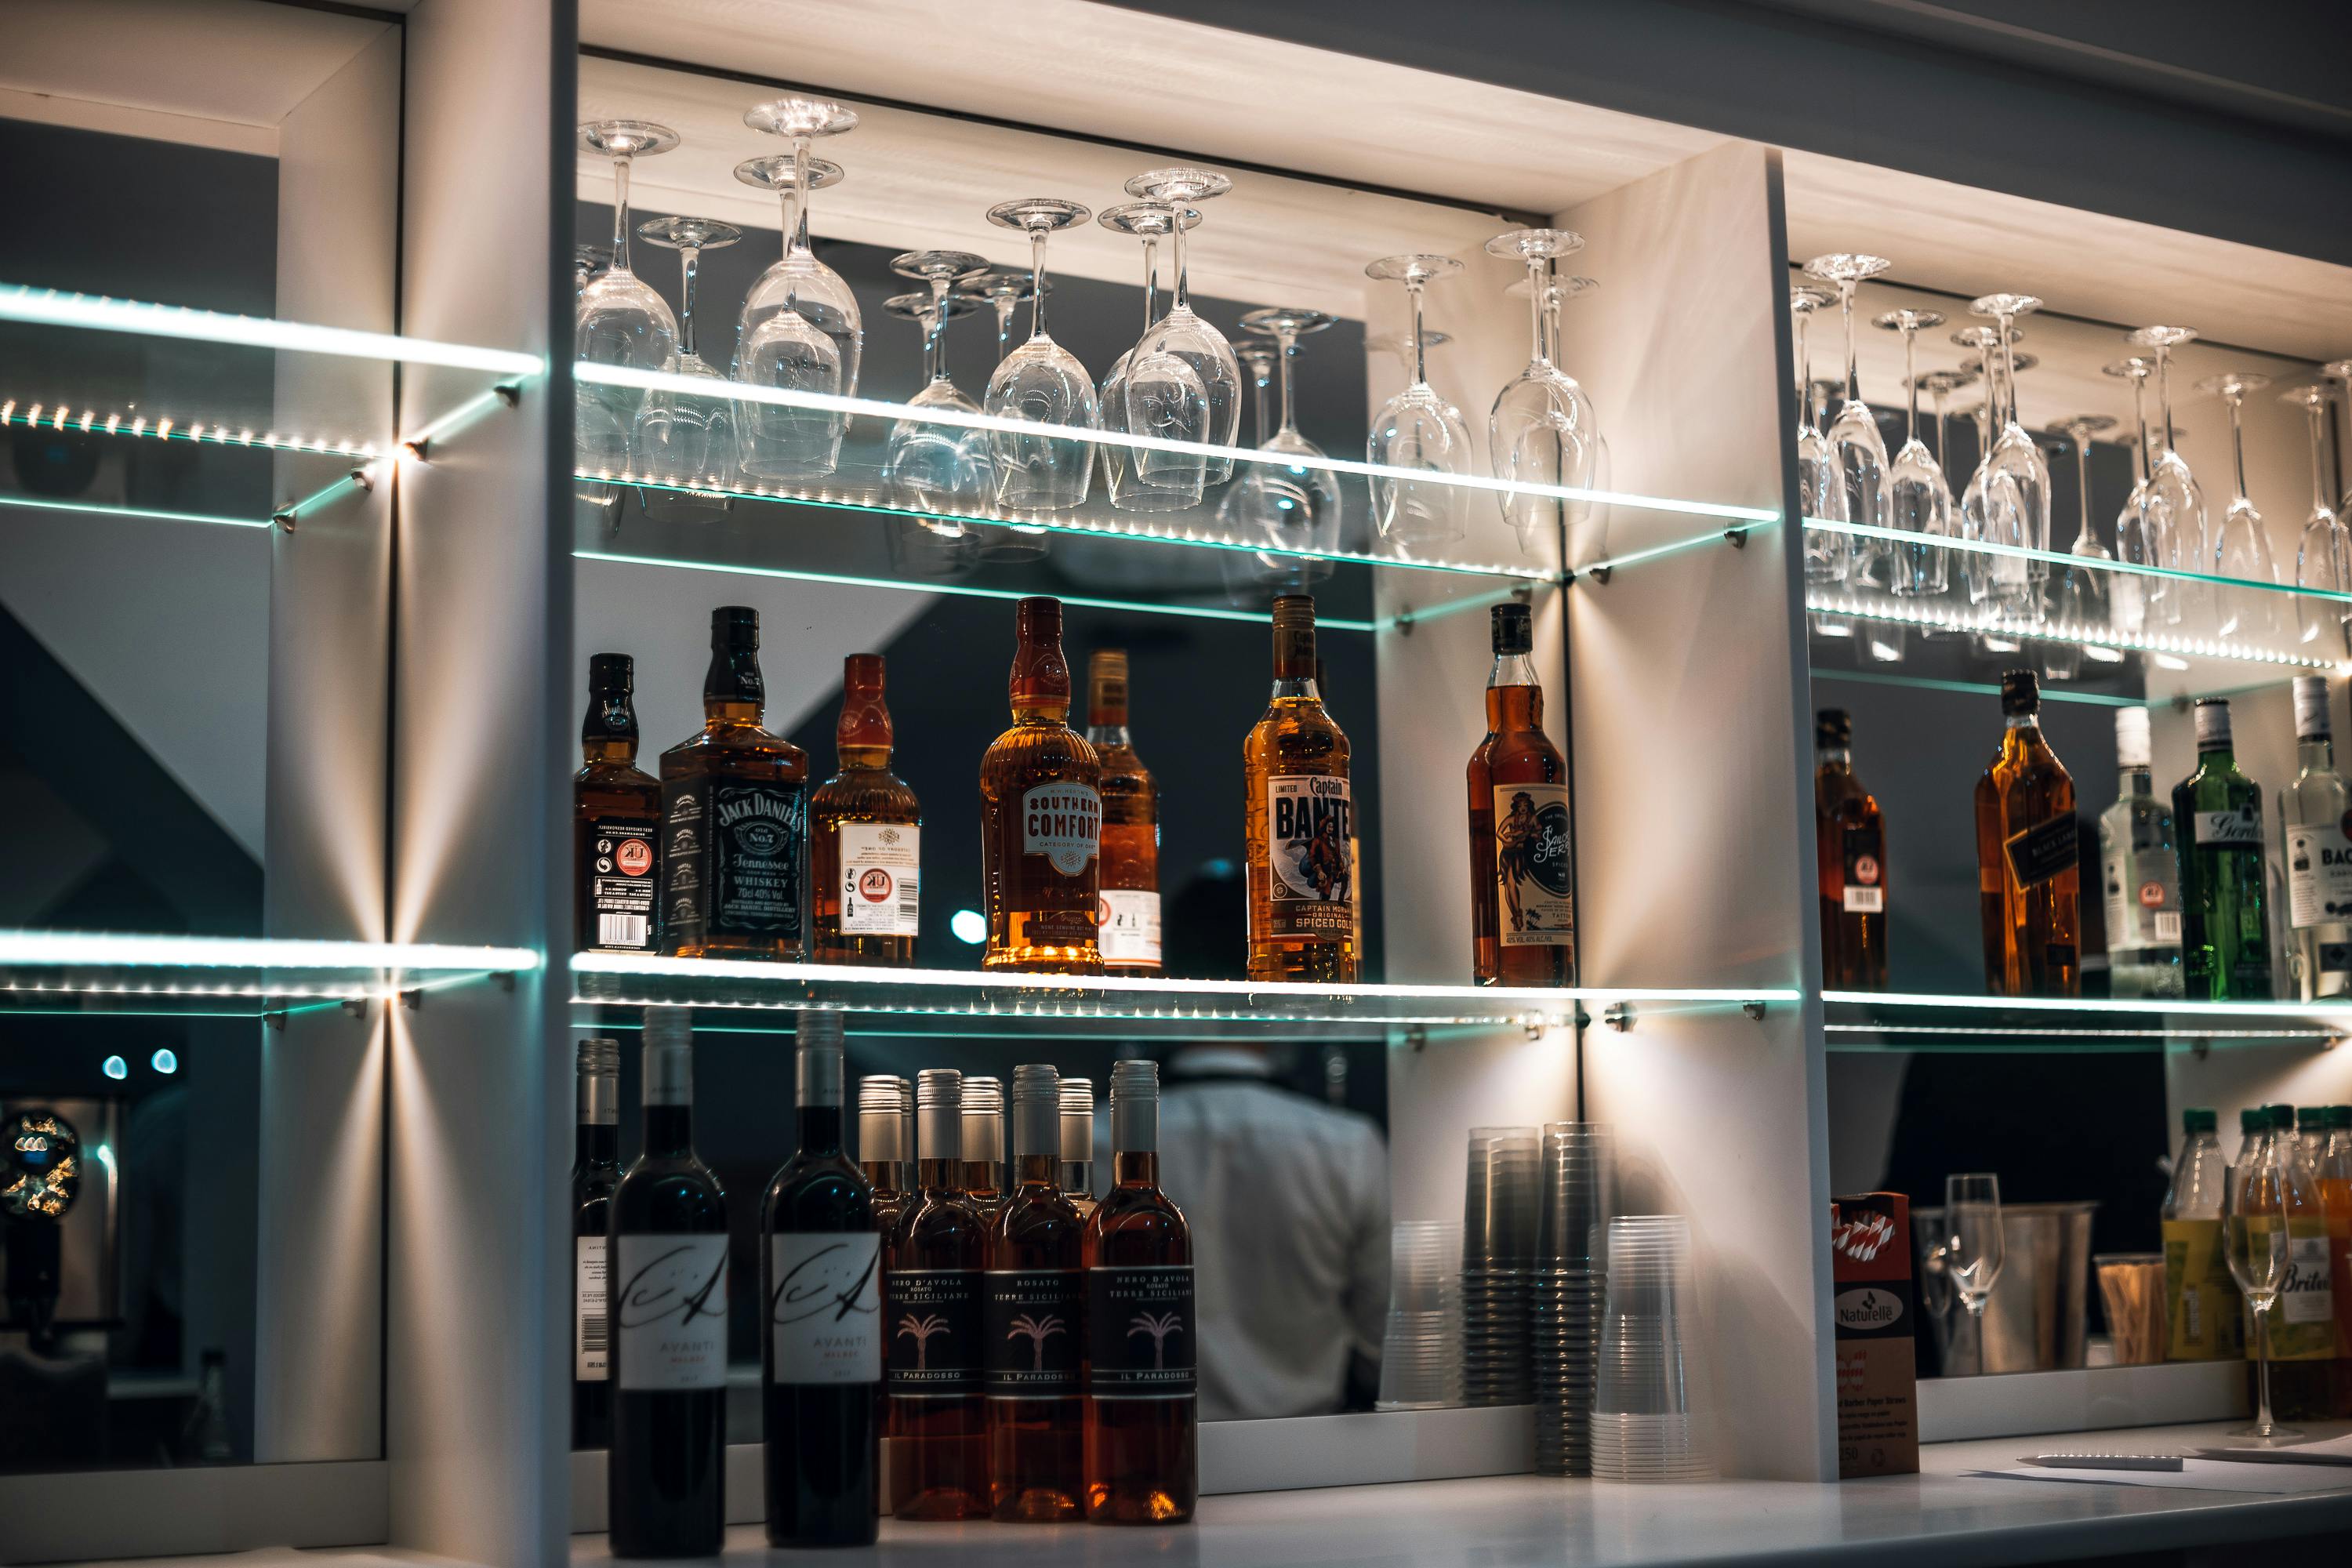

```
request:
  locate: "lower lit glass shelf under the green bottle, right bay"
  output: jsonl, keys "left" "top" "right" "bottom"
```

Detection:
{"left": 1820, "top": 989, "right": 2352, "bottom": 1051}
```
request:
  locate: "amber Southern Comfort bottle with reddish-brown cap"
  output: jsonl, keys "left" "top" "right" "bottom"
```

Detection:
{"left": 981, "top": 600, "right": 1103, "bottom": 975}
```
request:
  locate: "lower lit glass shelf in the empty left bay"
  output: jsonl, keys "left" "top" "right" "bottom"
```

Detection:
{"left": 0, "top": 931, "right": 539, "bottom": 1018}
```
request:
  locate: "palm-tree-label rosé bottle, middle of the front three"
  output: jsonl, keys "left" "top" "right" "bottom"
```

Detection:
{"left": 981, "top": 1065, "right": 1087, "bottom": 1523}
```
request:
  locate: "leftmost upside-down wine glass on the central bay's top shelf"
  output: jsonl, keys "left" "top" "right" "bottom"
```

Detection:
{"left": 572, "top": 120, "right": 677, "bottom": 508}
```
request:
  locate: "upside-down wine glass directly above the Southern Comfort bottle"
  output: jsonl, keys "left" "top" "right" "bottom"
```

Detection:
{"left": 985, "top": 195, "right": 1098, "bottom": 513}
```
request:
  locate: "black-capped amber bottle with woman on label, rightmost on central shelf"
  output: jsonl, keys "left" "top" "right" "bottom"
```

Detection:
{"left": 1468, "top": 604, "right": 1576, "bottom": 985}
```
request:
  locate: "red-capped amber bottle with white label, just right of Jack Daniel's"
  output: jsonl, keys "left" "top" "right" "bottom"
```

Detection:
{"left": 809, "top": 654, "right": 922, "bottom": 964}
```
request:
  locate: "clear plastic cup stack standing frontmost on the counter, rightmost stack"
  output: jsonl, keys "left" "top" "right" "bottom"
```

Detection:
{"left": 1592, "top": 1213, "right": 1715, "bottom": 1481}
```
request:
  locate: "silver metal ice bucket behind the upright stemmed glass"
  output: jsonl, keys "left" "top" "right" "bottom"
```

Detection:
{"left": 1912, "top": 1201, "right": 2098, "bottom": 1377}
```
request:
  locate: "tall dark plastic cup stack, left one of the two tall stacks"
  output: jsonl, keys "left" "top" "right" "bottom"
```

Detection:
{"left": 1463, "top": 1126, "right": 1541, "bottom": 1406}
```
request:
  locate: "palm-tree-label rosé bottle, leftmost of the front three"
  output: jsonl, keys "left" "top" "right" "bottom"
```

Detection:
{"left": 882, "top": 1067, "right": 990, "bottom": 1519}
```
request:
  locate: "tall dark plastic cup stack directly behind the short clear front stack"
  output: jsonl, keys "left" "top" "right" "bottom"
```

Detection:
{"left": 1529, "top": 1121, "right": 1616, "bottom": 1476}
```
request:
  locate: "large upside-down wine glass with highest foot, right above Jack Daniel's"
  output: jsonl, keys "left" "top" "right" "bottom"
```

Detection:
{"left": 734, "top": 148, "right": 866, "bottom": 480}
